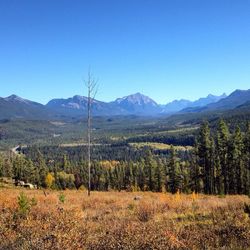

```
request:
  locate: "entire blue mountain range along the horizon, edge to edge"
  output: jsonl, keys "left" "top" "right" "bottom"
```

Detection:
{"left": 0, "top": 89, "right": 250, "bottom": 119}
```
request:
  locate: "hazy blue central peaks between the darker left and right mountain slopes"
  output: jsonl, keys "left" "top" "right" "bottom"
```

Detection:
{"left": 47, "top": 93, "right": 229, "bottom": 116}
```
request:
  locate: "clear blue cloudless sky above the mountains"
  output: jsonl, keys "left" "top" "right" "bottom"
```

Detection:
{"left": 0, "top": 0, "right": 250, "bottom": 104}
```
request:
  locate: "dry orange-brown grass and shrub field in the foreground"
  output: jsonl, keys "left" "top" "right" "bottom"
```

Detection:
{"left": 0, "top": 188, "right": 250, "bottom": 250}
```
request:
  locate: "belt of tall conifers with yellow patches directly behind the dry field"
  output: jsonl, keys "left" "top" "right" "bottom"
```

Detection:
{"left": 0, "top": 120, "right": 250, "bottom": 194}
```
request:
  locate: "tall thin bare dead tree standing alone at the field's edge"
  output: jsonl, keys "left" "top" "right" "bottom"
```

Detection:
{"left": 84, "top": 70, "right": 98, "bottom": 196}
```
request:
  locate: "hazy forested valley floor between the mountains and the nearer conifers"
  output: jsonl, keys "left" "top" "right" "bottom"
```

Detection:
{"left": 0, "top": 103, "right": 250, "bottom": 151}
